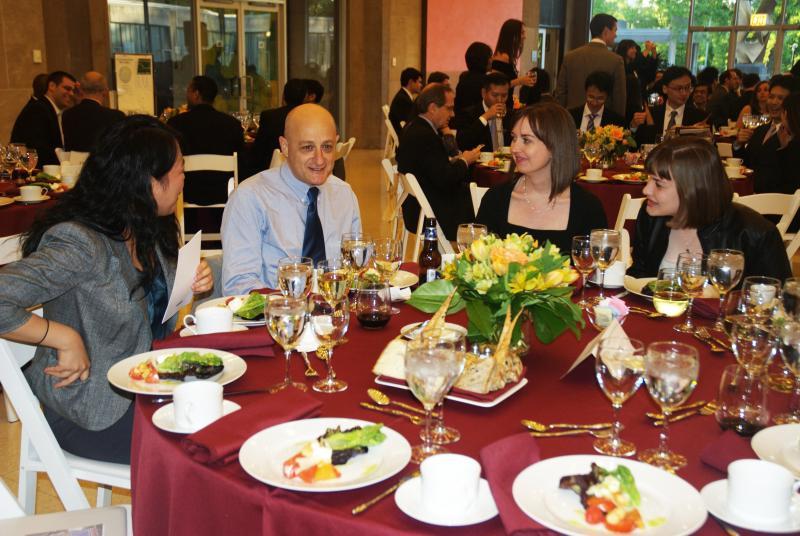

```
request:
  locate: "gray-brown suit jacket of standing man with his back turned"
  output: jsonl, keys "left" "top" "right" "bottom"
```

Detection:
{"left": 555, "top": 42, "right": 626, "bottom": 117}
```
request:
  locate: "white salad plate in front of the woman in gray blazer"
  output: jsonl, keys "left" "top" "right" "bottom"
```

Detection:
{"left": 108, "top": 348, "right": 247, "bottom": 395}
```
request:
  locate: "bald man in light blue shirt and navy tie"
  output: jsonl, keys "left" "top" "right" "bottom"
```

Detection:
{"left": 222, "top": 104, "right": 361, "bottom": 296}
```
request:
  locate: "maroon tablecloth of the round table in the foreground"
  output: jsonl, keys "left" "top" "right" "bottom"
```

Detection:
{"left": 131, "top": 282, "right": 786, "bottom": 536}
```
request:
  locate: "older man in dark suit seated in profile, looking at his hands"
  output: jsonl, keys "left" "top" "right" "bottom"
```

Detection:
{"left": 397, "top": 84, "right": 480, "bottom": 240}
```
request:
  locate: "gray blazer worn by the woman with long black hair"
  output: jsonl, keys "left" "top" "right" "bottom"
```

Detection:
{"left": 0, "top": 222, "right": 175, "bottom": 430}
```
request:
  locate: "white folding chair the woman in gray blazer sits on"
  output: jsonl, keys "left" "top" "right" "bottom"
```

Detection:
{"left": 0, "top": 318, "right": 131, "bottom": 514}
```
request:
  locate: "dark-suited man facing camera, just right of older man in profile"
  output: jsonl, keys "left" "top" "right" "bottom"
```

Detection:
{"left": 453, "top": 72, "right": 511, "bottom": 151}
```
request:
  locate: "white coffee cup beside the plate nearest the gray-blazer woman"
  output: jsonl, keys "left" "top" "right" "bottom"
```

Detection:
{"left": 172, "top": 380, "right": 222, "bottom": 432}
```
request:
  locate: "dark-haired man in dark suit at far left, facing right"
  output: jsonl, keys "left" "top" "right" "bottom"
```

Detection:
{"left": 11, "top": 71, "right": 75, "bottom": 166}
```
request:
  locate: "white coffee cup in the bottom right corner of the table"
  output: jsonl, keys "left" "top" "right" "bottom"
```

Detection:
{"left": 728, "top": 459, "right": 800, "bottom": 524}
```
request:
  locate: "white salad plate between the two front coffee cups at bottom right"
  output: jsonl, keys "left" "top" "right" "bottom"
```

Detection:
{"left": 511, "top": 455, "right": 708, "bottom": 536}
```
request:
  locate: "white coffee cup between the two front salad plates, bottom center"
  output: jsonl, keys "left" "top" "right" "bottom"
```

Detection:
{"left": 419, "top": 454, "right": 481, "bottom": 518}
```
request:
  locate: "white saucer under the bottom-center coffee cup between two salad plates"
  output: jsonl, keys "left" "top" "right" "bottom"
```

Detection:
{"left": 394, "top": 477, "right": 497, "bottom": 527}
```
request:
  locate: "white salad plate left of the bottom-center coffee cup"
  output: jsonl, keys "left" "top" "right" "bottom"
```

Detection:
{"left": 239, "top": 418, "right": 411, "bottom": 492}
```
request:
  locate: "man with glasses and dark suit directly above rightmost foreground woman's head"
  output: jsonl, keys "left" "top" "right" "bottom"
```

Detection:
{"left": 631, "top": 65, "right": 708, "bottom": 145}
